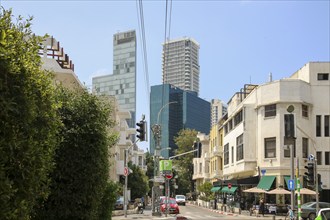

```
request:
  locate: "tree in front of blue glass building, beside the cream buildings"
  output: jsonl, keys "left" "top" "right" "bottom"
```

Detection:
{"left": 174, "top": 129, "right": 197, "bottom": 195}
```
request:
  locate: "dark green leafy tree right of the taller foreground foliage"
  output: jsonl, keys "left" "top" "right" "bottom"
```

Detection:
{"left": 34, "top": 88, "right": 116, "bottom": 220}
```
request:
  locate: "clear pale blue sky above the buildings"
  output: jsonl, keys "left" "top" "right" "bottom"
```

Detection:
{"left": 0, "top": 0, "right": 330, "bottom": 149}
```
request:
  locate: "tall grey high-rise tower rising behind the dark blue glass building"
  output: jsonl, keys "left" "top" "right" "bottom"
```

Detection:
{"left": 162, "top": 37, "right": 199, "bottom": 95}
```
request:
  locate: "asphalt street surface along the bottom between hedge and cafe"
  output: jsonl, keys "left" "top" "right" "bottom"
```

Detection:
{"left": 112, "top": 204, "right": 284, "bottom": 220}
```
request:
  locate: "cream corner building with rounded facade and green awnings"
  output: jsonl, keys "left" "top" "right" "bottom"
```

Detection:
{"left": 193, "top": 62, "right": 330, "bottom": 201}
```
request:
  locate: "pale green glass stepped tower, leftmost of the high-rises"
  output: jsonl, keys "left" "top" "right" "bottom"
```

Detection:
{"left": 92, "top": 30, "right": 136, "bottom": 128}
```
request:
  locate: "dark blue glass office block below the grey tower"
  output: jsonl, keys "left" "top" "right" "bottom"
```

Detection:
{"left": 150, "top": 84, "right": 211, "bottom": 158}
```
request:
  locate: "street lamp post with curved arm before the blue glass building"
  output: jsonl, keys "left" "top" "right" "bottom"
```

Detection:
{"left": 152, "top": 101, "right": 178, "bottom": 216}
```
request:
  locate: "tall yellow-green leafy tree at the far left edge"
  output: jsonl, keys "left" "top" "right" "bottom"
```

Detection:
{"left": 0, "top": 8, "right": 61, "bottom": 219}
